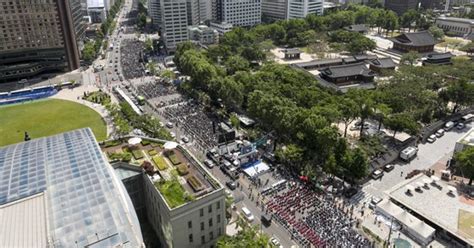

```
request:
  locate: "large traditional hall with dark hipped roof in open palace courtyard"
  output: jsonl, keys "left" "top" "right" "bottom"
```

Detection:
{"left": 390, "top": 31, "right": 436, "bottom": 53}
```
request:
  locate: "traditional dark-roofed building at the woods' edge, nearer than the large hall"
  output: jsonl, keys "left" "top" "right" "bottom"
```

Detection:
{"left": 320, "top": 63, "right": 375, "bottom": 85}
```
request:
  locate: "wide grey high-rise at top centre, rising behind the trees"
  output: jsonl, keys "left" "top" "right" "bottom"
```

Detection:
{"left": 214, "top": 0, "right": 262, "bottom": 27}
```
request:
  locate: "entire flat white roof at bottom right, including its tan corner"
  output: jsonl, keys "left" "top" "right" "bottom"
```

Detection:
{"left": 387, "top": 174, "right": 474, "bottom": 245}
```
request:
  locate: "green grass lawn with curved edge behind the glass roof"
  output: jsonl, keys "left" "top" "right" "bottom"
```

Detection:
{"left": 0, "top": 99, "right": 107, "bottom": 146}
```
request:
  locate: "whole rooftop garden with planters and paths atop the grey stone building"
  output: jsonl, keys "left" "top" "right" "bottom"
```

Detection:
{"left": 102, "top": 138, "right": 220, "bottom": 209}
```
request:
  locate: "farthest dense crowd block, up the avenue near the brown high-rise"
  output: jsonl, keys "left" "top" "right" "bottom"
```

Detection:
{"left": 120, "top": 40, "right": 145, "bottom": 79}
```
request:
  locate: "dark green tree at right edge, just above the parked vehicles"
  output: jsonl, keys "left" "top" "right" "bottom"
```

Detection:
{"left": 439, "top": 80, "right": 474, "bottom": 113}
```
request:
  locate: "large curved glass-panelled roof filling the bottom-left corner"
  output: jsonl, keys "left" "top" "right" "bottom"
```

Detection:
{"left": 0, "top": 128, "right": 143, "bottom": 247}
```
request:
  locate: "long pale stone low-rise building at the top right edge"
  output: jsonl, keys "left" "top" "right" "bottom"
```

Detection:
{"left": 435, "top": 16, "right": 474, "bottom": 37}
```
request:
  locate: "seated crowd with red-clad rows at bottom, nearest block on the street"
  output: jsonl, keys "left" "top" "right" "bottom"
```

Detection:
{"left": 267, "top": 182, "right": 370, "bottom": 247}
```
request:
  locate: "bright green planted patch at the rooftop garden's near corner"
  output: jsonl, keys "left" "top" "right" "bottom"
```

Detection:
{"left": 155, "top": 177, "right": 194, "bottom": 208}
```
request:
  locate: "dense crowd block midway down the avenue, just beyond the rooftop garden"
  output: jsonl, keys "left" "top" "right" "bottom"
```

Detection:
{"left": 160, "top": 100, "right": 217, "bottom": 151}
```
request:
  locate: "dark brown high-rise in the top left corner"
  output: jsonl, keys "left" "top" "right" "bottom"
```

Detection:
{"left": 0, "top": 0, "right": 85, "bottom": 82}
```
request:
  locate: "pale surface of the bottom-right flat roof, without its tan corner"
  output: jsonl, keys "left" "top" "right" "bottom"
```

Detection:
{"left": 387, "top": 174, "right": 474, "bottom": 245}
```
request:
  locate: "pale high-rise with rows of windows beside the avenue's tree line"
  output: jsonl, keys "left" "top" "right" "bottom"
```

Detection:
{"left": 160, "top": 0, "right": 189, "bottom": 52}
